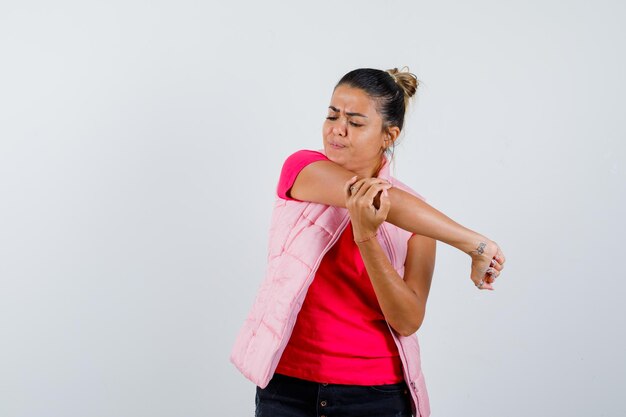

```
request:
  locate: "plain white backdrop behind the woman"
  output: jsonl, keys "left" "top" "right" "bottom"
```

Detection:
{"left": 0, "top": 0, "right": 626, "bottom": 417}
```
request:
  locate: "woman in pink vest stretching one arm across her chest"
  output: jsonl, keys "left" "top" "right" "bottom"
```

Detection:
{"left": 231, "top": 69, "right": 505, "bottom": 417}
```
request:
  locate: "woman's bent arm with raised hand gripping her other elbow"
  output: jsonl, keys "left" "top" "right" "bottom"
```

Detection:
{"left": 345, "top": 177, "right": 436, "bottom": 336}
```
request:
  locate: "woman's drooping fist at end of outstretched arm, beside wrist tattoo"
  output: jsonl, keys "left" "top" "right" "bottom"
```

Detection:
{"left": 469, "top": 238, "right": 506, "bottom": 290}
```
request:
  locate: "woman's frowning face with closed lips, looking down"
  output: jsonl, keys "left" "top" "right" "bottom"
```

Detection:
{"left": 322, "top": 85, "right": 397, "bottom": 177}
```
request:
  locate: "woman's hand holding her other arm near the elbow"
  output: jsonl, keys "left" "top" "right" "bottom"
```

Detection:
{"left": 345, "top": 176, "right": 391, "bottom": 241}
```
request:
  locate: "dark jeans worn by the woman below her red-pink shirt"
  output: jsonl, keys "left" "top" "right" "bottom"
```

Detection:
{"left": 255, "top": 374, "right": 412, "bottom": 417}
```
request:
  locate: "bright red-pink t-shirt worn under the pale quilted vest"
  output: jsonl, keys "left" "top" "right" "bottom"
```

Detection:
{"left": 276, "top": 150, "right": 403, "bottom": 385}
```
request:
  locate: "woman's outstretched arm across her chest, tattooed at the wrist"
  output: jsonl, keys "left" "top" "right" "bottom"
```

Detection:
{"left": 290, "top": 161, "right": 505, "bottom": 289}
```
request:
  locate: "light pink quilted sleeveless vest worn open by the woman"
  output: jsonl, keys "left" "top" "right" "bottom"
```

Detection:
{"left": 230, "top": 156, "right": 430, "bottom": 417}
